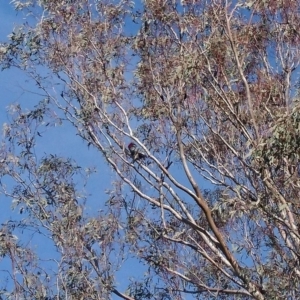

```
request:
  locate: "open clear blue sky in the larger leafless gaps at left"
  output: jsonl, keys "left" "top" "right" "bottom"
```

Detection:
{"left": 0, "top": 1, "right": 199, "bottom": 299}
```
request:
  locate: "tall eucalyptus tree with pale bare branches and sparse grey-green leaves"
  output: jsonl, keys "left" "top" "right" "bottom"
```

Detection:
{"left": 0, "top": 0, "right": 300, "bottom": 299}
